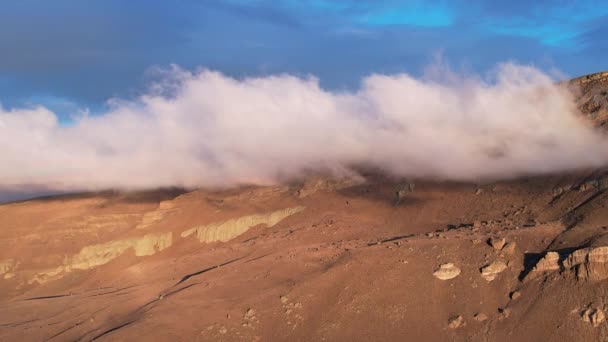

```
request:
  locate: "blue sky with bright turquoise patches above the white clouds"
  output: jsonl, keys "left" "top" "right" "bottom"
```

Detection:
{"left": 0, "top": 0, "right": 608, "bottom": 121}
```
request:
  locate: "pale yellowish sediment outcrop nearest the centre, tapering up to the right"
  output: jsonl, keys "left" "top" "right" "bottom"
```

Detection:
{"left": 181, "top": 206, "right": 305, "bottom": 243}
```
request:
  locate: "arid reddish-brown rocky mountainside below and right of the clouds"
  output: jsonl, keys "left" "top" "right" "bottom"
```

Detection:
{"left": 0, "top": 74, "right": 608, "bottom": 341}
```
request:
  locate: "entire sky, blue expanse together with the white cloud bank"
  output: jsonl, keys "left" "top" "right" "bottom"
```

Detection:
{"left": 0, "top": 0, "right": 608, "bottom": 202}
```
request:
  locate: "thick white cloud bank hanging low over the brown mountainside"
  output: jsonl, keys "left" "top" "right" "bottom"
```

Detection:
{"left": 0, "top": 64, "right": 608, "bottom": 190}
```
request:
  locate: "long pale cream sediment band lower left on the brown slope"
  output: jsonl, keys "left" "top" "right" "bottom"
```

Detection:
{"left": 29, "top": 232, "right": 173, "bottom": 284}
